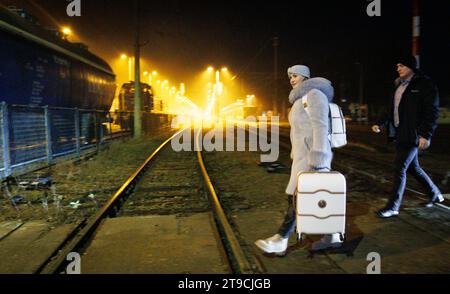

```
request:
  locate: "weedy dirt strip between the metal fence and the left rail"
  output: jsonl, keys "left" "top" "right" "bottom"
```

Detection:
{"left": 0, "top": 132, "right": 169, "bottom": 224}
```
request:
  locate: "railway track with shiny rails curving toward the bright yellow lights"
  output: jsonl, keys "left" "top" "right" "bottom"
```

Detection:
{"left": 36, "top": 129, "right": 255, "bottom": 274}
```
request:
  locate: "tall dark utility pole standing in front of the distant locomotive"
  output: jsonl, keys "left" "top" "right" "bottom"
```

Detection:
{"left": 134, "top": 0, "right": 142, "bottom": 139}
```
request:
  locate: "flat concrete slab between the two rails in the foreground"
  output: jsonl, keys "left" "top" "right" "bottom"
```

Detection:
{"left": 81, "top": 213, "right": 229, "bottom": 274}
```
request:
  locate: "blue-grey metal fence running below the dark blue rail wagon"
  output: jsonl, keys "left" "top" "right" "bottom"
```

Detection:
{"left": 0, "top": 102, "right": 137, "bottom": 179}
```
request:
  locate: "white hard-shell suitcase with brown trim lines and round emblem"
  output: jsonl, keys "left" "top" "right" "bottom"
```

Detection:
{"left": 296, "top": 171, "right": 346, "bottom": 240}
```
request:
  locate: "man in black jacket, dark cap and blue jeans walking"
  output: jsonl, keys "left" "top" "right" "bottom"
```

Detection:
{"left": 372, "top": 56, "right": 444, "bottom": 218}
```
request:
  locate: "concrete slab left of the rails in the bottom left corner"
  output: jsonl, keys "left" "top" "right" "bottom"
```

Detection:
{"left": 0, "top": 221, "right": 74, "bottom": 274}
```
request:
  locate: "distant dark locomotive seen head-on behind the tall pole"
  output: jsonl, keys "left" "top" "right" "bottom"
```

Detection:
{"left": 119, "top": 82, "right": 153, "bottom": 112}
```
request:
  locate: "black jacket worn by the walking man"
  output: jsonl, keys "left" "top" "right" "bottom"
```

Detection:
{"left": 379, "top": 72, "right": 439, "bottom": 146}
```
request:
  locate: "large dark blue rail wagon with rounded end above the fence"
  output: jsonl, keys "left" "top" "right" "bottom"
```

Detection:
{"left": 0, "top": 7, "right": 116, "bottom": 111}
